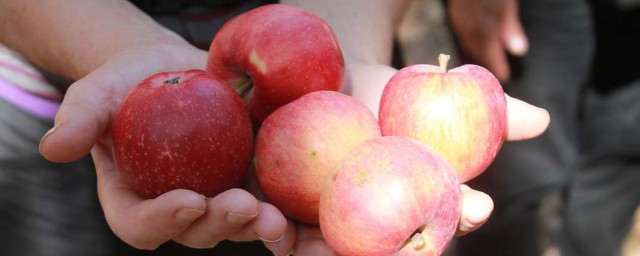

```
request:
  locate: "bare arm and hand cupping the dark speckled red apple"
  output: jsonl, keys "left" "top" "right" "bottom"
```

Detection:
{"left": 0, "top": 0, "right": 293, "bottom": 255}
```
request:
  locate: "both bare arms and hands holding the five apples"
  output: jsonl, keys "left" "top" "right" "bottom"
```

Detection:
{"left": 0, "top": 0, "right": 549, "bottom": 255}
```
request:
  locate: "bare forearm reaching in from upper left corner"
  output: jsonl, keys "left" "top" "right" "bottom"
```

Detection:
{"left": 0, "top": 0, "right": 186, "bottom": 79}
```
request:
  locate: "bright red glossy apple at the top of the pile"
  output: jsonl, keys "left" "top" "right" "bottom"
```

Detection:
{"left": 207, "top": 4, "right": 345, "bottom": 124}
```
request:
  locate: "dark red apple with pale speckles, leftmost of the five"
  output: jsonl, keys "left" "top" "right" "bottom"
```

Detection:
{"left": 112, "top": 70, "right": 253, "bottom": 198}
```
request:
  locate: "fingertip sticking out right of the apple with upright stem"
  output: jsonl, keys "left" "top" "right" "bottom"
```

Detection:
{"left": 506, "top": 95, "right": 550, "bottom": 141}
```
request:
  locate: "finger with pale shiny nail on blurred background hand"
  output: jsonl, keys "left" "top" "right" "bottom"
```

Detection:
{"left": 502, "top": 0, "right": 529, "bottom": 57}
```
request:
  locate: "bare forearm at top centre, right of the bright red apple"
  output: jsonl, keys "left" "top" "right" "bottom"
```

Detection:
{"left": 282, "top": 0, "right": 409, "bottom": 65}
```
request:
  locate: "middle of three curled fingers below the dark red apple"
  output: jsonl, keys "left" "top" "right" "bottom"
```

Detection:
{"left": 174, "top": 189, "right": 260, "bottom": 248}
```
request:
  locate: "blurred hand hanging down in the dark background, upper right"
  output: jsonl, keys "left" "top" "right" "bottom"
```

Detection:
{"left": 448, "top": 0, "right": 529, "bottom": 83}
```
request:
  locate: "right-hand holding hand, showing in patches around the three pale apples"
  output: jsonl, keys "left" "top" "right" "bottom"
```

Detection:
{"left": 268, "top": 64, "right": 549, "bottom": 255}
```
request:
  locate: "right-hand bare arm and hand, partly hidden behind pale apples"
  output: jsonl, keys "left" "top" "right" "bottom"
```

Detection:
{"left": 282, "top": 0, "right": 549, "bottom": 255}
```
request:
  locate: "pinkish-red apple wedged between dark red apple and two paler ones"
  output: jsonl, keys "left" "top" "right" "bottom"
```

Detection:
{"left": 253, "top": 91, "right": 381, "bottom": 225}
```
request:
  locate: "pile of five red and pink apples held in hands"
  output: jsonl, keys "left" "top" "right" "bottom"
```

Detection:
{"left": 112, "top": 4, "right": 506, "bottom": 255}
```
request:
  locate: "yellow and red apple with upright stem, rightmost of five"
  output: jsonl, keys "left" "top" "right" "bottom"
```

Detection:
{"left": 378, "top": 55, "right": 507, "bottom": 182}
